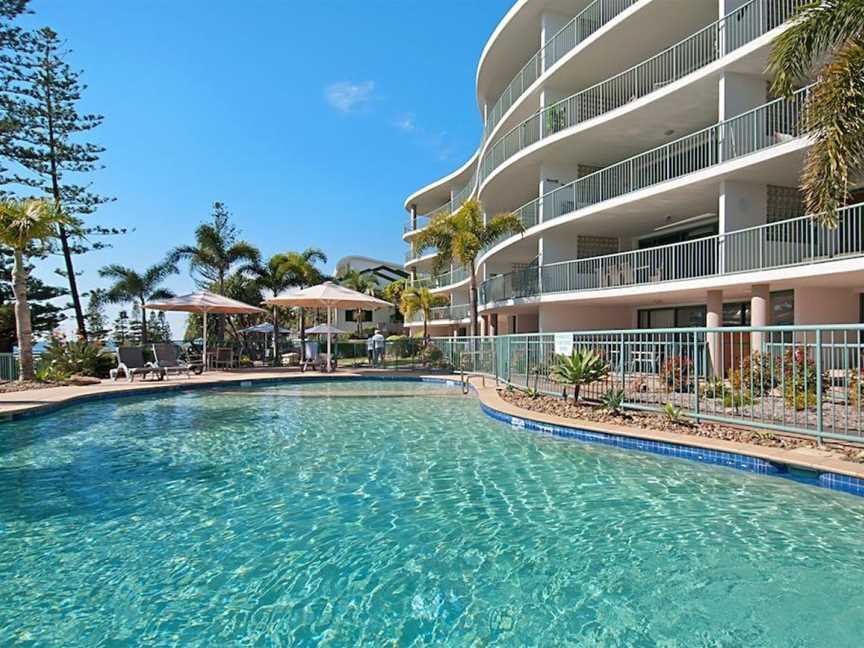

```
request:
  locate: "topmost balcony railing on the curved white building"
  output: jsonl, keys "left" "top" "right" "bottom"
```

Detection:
{"left": 483, "top": 0, "right": 636, "bottom": 138}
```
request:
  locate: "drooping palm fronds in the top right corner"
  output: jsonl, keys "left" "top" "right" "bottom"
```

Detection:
{"left": 768, "top": 0, "right": 864, "bottom": 227}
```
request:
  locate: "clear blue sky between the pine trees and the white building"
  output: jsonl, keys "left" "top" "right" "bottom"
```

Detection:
{"left": 24, "top": 0, "right": 512, "bottom": 336}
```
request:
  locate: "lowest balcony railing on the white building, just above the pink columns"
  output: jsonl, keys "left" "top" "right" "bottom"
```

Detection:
{"left": 479, "top": 203, "right": 864, "bottom": 304}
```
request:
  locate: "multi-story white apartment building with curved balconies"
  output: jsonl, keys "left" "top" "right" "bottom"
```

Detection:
{"left": 403, "top": 0, "right": 864, "bottom": 350}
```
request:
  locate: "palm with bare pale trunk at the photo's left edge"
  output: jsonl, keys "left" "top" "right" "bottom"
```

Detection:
{"left": 0, "top": 200, "right": 70, "bottom": 381}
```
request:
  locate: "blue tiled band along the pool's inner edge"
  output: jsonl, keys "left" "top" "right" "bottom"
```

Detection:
{"left": 0, "top": 376, "right": 864, "bottom": 497}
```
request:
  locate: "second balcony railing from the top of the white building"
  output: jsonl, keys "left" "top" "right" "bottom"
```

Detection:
{"left": 480, "top": 0, "right": 808, "bottom": 187}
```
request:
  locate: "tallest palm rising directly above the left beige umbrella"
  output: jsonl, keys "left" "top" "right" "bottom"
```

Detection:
{"left": 168, "top": 203, "right": 261, "bottom": 343}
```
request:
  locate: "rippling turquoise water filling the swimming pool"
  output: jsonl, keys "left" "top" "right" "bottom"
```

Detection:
{"left": 0, "top": 382, "right": 864, "bottom": 647}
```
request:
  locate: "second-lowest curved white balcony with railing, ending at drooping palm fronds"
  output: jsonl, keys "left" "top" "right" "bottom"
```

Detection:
{"left": 479, "top": 86, "right": 810, "bottom": 262}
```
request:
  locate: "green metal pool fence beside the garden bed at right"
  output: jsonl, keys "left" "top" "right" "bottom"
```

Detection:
{"left": 432, "top": 325, "right": 864, "bottom": 441}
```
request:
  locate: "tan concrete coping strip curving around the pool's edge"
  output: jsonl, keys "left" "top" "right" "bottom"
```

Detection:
{"left": 0, "top": 369, "right": 864, "bottom": 480}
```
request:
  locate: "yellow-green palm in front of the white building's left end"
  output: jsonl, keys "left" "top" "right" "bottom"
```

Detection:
{"left": 414, "top": 198, "right": 525, "bottom": 336}
